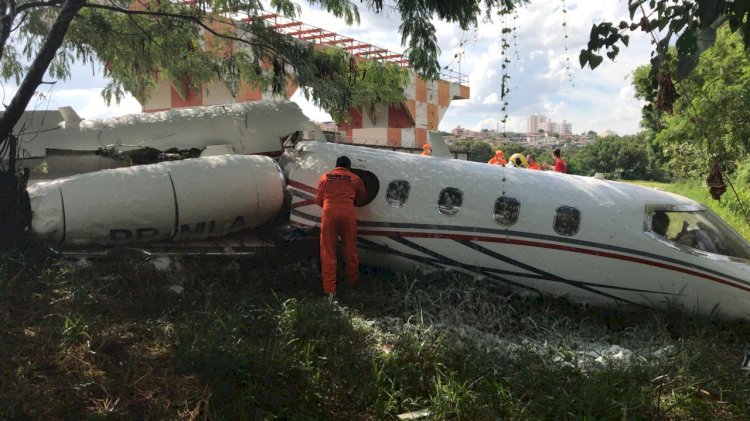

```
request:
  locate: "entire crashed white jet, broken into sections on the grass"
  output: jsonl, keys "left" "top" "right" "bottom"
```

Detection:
{"left": 14, "top": 101, "right": 750, "bottom": 319}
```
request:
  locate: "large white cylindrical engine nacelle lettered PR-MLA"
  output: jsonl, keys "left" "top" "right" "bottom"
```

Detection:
{"left": 28, "top": 155, "right": 284, "bottom": 245}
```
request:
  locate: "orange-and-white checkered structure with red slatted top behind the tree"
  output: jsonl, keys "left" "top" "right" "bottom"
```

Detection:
{"left": 137, "top": 9, "right": 470, "bottom": 148}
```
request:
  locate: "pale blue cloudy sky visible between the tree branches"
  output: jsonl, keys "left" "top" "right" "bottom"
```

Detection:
{"left": 1, "top": 0, "right": 651, "bottom": 135}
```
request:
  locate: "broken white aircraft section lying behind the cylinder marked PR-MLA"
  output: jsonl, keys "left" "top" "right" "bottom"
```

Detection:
{"left": 20, "top": 100, "right": 314, "bottom": 177}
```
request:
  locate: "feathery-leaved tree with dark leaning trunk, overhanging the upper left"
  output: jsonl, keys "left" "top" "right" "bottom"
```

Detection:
{"left": 0, "top": 0, "right": 525, "bottom": 235}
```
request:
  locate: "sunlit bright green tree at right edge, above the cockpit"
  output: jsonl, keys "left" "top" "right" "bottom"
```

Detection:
{"left": 633, "top": 28, "right": 750, "bottom": 178}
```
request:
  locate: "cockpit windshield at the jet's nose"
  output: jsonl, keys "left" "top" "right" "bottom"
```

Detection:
{"left": 646, "top": 208, "right": 750, "bottom": 260}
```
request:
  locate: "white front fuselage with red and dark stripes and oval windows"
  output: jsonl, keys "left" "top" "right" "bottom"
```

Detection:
{"left": 282, "top": 142, "right": 750, "bottom": 318}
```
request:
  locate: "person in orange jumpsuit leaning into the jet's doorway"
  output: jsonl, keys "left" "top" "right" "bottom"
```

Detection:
{"left": 316, "top": 156, "right": 367, "bottom": 296}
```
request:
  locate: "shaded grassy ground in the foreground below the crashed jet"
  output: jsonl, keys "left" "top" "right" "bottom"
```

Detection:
{"left": 0, "top": 241, "right": 750, "bottom": 420}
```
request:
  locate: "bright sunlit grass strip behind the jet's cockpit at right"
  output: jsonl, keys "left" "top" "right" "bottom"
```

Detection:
{"left": 635, "top": 180, "right": 750, "bottom": 241}
